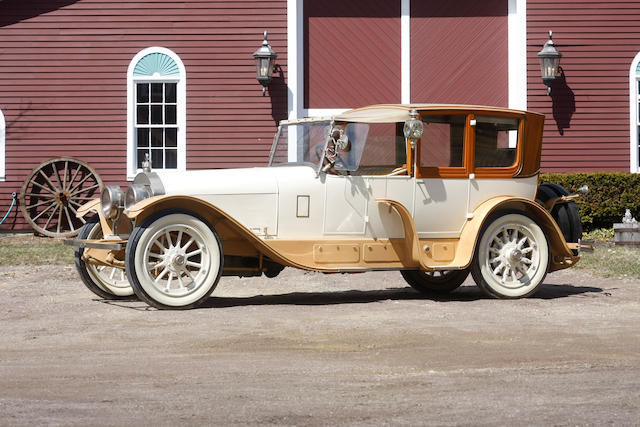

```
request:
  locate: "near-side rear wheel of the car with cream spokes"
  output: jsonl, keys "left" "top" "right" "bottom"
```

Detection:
{"left": 471, "top": 213, "right": 549, "bottom": 298}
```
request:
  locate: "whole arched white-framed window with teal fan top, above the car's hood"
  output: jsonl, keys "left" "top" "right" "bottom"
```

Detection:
{"left": 127, "top": 47, "right": 187, "bottom": 179}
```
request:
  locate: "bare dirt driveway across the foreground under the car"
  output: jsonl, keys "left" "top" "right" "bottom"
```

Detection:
{"left": 0, "top": 266, "right": 640, "bottom": 425}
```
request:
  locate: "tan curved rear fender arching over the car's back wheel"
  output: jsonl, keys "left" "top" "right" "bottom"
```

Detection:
{"left": 452, "top": 197, "right": 580, "bottom": 271}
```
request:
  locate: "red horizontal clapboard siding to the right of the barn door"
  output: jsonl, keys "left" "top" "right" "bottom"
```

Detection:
{"left": 527, "top": 0, "right": 640, "bottom": 172}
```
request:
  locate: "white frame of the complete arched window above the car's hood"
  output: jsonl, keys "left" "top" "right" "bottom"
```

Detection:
{"left": 127, "top": 46, "right": 187, "bottom": 181}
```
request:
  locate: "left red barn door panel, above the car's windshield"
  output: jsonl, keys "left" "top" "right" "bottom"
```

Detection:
{"left": 304, "top": 0, "right": 401, "bottom": 108}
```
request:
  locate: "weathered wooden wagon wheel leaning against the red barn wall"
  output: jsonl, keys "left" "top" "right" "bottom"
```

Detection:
{"left": 20, "top": 157, "right": 102, "bottom": 237}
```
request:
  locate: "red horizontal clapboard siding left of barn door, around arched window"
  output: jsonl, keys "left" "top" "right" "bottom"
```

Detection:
{"left": 0, "top": 0, "right": 287, "bottom": 229}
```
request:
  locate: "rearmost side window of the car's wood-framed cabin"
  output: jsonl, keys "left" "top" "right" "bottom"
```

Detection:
{"left": 475, "top": 116, "right": 520, "bottom": 168}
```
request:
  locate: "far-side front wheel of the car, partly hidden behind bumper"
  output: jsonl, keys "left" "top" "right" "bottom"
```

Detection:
{"left": 74, "top": 221, "right": 133, "bottom": 299}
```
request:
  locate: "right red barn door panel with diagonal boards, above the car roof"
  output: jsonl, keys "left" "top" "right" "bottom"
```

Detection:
{"left": 411, "top": 0, "right": 509, "bottom": 107}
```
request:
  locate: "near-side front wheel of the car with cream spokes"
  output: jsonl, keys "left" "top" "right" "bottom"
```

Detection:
{"left": 126, "top": 212, "right": 223, "bottom": 309}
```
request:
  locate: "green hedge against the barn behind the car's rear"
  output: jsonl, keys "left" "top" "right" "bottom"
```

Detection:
{"left": 540, "top": 172, "right": 640, "bottom": 231}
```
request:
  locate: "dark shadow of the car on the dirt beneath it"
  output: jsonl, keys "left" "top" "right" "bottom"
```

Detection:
{"left": 98, "top": 285, "right": 610, "bottom": 310}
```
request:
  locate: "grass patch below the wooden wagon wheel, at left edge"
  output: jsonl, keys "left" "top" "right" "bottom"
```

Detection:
{"left": 0, "top": 235, "right": 74, "bottom": 267}
